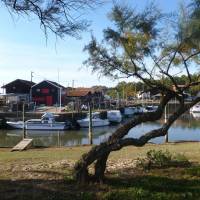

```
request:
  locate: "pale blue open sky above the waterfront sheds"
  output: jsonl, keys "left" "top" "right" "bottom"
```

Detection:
{"left": 0, "top": 0, "right": 191, "bottom": 92}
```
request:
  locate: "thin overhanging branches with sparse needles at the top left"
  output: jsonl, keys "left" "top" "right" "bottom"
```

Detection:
{"left": 1, "top": 0, "right": 102, "bottom": 38}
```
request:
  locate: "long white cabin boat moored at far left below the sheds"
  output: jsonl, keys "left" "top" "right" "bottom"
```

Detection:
{"left": 7, "top": 113, "right": 71, "bottom": 130}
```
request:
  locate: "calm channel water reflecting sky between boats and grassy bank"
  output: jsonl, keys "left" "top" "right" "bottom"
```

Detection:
{"left": 0, "top": 114, "right": 200, "bottom": 147}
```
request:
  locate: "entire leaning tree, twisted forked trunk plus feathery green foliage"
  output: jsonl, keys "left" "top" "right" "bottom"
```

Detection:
{"left": 75, "top": 0, "right": 200, "bottom": 183}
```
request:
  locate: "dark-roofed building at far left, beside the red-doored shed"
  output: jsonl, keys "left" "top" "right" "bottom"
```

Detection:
{"left": 0, "top": 79, "right": 35, "bottom": 104}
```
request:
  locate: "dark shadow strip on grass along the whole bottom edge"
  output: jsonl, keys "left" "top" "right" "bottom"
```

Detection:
{"left": 0, "top": 170, "right": 200, "bottom": 200}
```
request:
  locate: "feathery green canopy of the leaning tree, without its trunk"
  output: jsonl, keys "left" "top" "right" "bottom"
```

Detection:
{"left": 84, "top": 1, "right": 200, "bottom": 95}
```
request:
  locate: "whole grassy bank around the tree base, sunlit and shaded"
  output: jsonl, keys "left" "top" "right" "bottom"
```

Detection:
{"left": 0, "top": 142, "right": 200, "bottom": 200}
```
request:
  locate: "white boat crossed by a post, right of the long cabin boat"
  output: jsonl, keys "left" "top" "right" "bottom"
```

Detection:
{"left": 77, "top": 112, "right": 110, "bottom": 128}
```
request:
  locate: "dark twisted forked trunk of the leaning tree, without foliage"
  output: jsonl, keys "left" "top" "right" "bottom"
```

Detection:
{"left": 74, "top": 96, "right": 200, "bottom": 184}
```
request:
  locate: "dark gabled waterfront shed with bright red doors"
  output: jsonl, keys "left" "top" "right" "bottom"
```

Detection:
{"left": 30, "top": 80, "right": 65, "bottom": 106}
